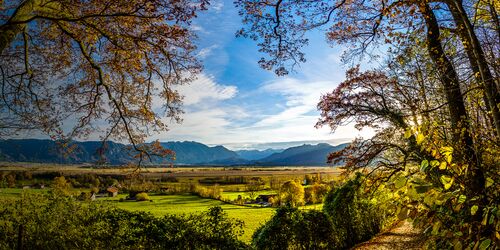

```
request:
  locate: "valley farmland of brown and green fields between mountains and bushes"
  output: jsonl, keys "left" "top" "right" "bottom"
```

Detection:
{"left": 0, "top": 164, "right": 340, "bottom": 242}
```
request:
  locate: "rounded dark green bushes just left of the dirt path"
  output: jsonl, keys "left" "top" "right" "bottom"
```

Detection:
{"left": 252, "top": 176, "right": 385, "bottom": 249}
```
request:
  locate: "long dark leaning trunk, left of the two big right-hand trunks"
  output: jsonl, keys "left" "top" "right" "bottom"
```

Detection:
{"left": 418, "top": 4, "right": 484, "bottom": 195}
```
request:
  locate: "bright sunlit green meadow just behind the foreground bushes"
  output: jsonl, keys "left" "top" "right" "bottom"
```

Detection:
{"left": 106, "top": 194, "right": 275, "bottom": 242}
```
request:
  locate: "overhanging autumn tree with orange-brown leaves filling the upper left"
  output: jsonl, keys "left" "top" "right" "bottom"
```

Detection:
{"left": 0, "top": 0, "right": 208, "bottom": 159}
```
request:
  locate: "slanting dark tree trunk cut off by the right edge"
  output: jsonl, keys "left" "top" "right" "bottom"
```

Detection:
{"left": 447, "top": 0, "right": 500, "bottom": 138}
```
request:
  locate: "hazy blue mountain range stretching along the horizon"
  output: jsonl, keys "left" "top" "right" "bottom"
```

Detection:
{"left": 0, "top": 139, "right": 347, "bottom": 166}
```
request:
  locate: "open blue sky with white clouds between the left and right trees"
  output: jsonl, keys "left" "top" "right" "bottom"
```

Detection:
{"left": 150, "top": 0, "right": 371, "bottom": 149}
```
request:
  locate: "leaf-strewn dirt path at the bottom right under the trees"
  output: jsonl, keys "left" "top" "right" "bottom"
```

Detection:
{"left": 353, "top": 221, "right": 424, "bottom": 250}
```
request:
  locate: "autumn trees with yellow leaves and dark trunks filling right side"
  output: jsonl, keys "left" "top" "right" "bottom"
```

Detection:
{"left": 236, "top": 0, "right": 500, "bottom": 248}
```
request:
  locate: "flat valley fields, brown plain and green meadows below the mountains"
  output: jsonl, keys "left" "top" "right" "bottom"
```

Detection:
{"left": 0, "top": 163, "right": 341, "bottom": 242}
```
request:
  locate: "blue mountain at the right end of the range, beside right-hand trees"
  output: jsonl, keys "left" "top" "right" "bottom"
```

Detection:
{"left": 256, "top": 143, "right": 348, "bottom": 166}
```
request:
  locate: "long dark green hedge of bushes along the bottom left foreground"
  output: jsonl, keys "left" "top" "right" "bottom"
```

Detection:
{"left": 0, "top": 194, "right": 245, "bottom": 249}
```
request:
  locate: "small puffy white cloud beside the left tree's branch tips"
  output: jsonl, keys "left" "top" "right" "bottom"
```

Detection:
{"left": 175, "top": 74, "right": 238, "bottom": 106}
